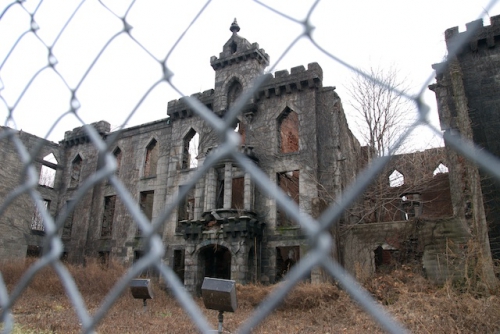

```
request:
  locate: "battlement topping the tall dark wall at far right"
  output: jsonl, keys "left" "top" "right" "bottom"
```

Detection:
{"left": 444, "top": 15, "right": 500, "bottom": 53}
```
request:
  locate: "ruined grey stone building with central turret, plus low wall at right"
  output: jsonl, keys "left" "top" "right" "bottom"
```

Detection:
{"left": 0, "top": 18, "right": 496, "bottom": 292}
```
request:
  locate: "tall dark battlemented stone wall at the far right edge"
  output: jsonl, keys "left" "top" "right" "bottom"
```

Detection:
{"left": 430, "top": 16, "right": 500, "bottom": 258}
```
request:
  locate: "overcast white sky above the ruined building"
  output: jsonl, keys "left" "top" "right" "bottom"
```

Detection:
{"left": 0, "top": 0, "right": 500, "bottom": 146}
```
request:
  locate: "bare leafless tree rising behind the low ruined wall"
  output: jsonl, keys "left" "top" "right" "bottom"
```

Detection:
{"left": 347, "top": 67, "right": 415, "bottom": 155}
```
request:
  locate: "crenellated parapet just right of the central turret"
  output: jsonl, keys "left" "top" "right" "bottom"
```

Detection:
{"left": 257, "top": 63, "right": 323, "bottom": 99}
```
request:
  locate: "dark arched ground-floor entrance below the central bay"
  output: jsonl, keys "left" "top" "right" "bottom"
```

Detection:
{"left": 200, "top": 244, "right": 231, "bottom": 279}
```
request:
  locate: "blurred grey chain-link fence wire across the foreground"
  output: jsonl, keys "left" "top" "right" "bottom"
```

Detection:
{"left": 0, "top": 0, "right": 500, "bottom": 333}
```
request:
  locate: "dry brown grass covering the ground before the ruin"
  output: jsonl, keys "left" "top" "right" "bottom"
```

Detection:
{"left": 1, "top": 262, "right": 500, "bottom": 334}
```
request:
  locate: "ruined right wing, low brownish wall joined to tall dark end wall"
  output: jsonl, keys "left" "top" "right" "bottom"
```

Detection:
{"left": 340, "top": 16, "right": 500, "bottom": 282}
